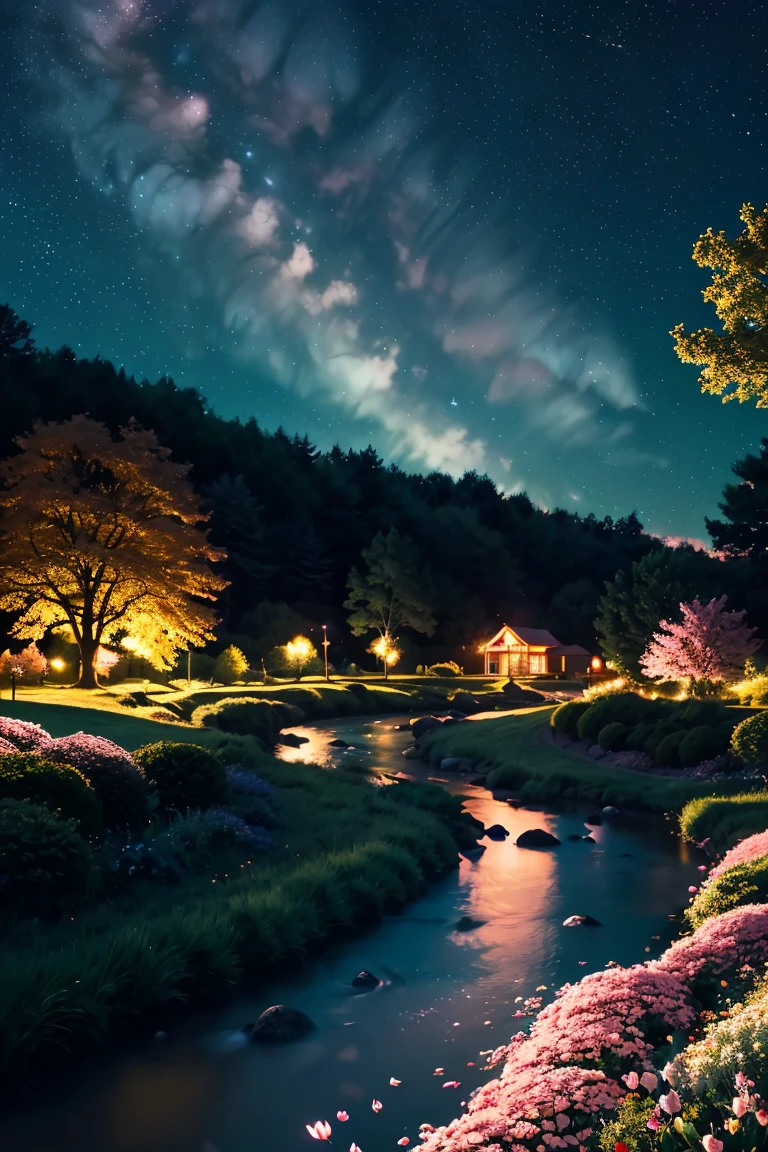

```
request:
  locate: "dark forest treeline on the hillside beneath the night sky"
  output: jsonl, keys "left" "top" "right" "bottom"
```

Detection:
{"left": 0, "top": 313, "right": 759, "bottom": 672}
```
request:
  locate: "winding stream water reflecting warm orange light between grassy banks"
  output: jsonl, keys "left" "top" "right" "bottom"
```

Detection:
{"left": 0, "top": 719, "right": 700, "bottom": 1152}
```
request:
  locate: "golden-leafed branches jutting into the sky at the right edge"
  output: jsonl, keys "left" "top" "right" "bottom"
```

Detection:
{"left": 670, "top": 204, "right": 768, "bottom": 408}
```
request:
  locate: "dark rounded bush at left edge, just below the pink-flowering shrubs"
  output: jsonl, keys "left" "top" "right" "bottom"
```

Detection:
{"left": 0, "top": 752, "right": 104, "bottom": 836}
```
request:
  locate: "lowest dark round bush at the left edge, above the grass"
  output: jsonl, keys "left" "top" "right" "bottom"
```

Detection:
{"left": 0, "top": 799, "right": 94, "bottom": 916}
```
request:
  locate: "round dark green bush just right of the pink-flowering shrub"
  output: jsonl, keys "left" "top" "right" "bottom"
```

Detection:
{"left": 134, "top": 740, "right": 227, "bottom": 811}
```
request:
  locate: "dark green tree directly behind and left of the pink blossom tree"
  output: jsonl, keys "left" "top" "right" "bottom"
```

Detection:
{"left": 595, "top": 545, "right": 723, "bottom": 677}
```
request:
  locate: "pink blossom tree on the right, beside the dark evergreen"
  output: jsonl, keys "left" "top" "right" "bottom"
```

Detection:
{"left": 640, "top": 596, "right": 762, "bottom": 684}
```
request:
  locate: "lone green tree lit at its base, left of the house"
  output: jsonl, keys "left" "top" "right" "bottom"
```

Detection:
{"left": 344, "top": 528, "right": 435, "bottom": 675}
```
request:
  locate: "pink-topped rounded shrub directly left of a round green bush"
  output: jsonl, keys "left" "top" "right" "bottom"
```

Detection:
{"left": 41, "top": 732, "right": 149, "bottom": 828}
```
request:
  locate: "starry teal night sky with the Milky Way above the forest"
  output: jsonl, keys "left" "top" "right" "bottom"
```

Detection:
{"left": 0, "top": 0, "right": 768, "bottom": 538}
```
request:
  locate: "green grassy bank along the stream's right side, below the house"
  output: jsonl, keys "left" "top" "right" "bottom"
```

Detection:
{"left": 416, "top": 707, "right": 746, "bottom": 826}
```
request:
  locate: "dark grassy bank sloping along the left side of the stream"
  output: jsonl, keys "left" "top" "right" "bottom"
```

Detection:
{"left": 0, "top": 732, "right": 470, "bottom": 1081}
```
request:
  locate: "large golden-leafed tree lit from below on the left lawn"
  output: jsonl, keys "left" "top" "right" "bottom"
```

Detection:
{"left": 0, "top": 416, "right": 226, "bottom": 688}
